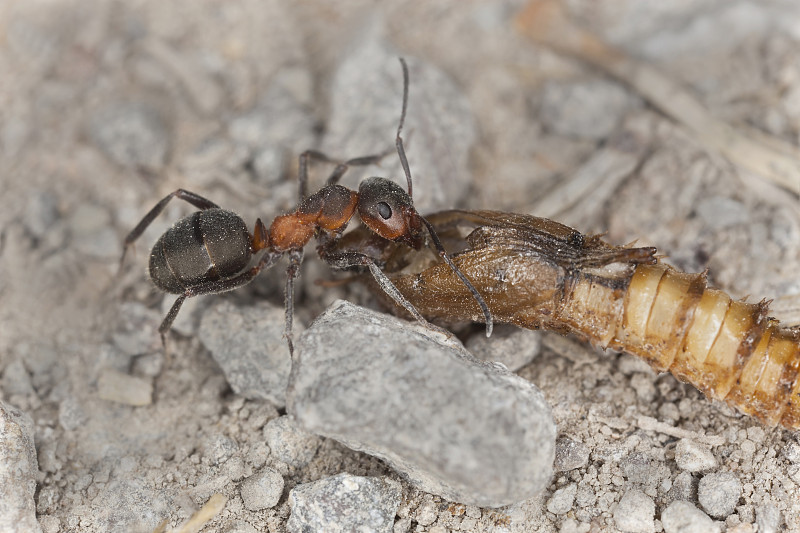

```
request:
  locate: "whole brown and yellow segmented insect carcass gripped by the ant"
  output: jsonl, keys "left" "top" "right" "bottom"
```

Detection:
{"left": 354, "top": 211, "right": 800, "bottom": 429}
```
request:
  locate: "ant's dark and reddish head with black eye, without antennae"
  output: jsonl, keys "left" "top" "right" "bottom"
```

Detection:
{"left": 358, "top": 178, "right": 422, "bottom": 250}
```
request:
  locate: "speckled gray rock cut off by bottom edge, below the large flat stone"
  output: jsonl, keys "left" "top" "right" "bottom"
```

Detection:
{"left": 286, "top": 474, "right": 402, "bottom": 533}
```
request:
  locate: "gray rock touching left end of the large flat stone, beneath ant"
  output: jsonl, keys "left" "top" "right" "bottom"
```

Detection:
{"left": 198, "top": 299, "right": 292, "bottom": 407}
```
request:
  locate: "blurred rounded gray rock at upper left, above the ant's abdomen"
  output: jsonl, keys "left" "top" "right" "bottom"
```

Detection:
{"left": 89, "top": 102, "right": 172, "bottom": 169}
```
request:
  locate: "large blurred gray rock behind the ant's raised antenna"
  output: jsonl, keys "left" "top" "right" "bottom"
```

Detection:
{"left": 323, "top": 41, "right": 477, "bottom": 213}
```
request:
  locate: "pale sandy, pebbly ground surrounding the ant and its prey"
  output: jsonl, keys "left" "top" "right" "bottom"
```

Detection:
{"left": 0, "top": 0, "right": 800, "bottom": 533}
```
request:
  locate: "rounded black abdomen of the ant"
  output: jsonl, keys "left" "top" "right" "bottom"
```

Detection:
{"left": 149, "top": 208, "right": 252, "bottom": 294}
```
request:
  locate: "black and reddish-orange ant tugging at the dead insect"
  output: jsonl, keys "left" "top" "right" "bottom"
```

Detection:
{"left": 120, "top": 58, "right": 492, "bottom": 355}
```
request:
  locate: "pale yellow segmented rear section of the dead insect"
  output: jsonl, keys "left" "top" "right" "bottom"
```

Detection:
{"left": 560, "top": 264, "right": 800, "bottom": 428}
